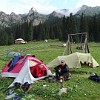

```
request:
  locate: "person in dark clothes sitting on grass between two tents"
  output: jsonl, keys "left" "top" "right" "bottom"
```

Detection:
{"left": 54, "top": 60, "right": 70, "bottom": 80}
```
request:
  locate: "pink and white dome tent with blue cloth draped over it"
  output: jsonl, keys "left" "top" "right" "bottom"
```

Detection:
{"left": 1, "top": 55, "right": 52, "bottom": 83}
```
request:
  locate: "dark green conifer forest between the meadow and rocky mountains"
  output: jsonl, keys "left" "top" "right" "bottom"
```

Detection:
{"left": 0, "top": 13, "right": 100, "bottom": 45}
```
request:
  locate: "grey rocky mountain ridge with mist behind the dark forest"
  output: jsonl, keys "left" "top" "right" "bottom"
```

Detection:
{"left": 0, "top": 5, "right": 100, "bottom": 27}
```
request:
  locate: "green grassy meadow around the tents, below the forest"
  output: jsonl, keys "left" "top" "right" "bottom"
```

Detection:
{"left": 0, "top": 40, "right": 100, "bottom": 100}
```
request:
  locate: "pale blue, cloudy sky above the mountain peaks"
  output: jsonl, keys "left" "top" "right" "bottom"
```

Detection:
{"left": 0, "top": 0, "right": 100, "bottom": 14}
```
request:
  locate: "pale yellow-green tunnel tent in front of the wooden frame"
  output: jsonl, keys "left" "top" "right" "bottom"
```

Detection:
{"left": 47, "top": 52, "right": 99, "bottom": 68}
